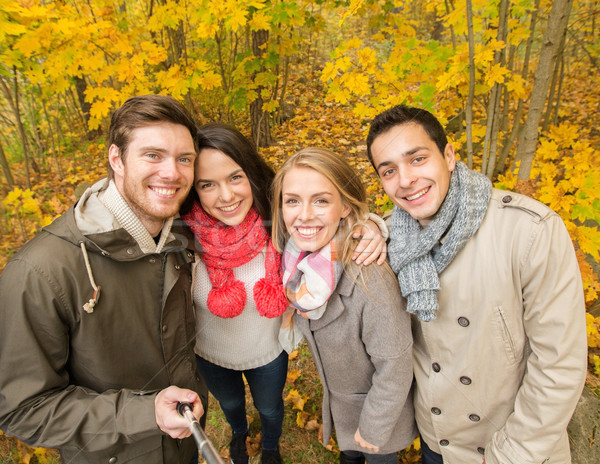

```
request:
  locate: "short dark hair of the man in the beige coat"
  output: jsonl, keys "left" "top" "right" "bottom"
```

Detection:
{"left": 367, "top": 105, "right": 448, "bottom": 164}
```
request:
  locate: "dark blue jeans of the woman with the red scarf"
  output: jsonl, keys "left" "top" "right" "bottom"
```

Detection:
{"left": 196, "top": 351, "right": 288, "bottom": 450}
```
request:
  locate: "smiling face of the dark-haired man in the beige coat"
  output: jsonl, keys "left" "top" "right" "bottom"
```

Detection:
{"left": 371, "top": 123, "right": 456, "bottom": 226}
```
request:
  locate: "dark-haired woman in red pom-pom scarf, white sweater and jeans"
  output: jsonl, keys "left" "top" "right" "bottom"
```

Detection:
{"left": 183, "top": 124, "right": 385, "bottom": 464}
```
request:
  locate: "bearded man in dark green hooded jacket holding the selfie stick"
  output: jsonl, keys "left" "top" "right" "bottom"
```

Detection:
{"left": 0, "top": 95, "right": 206, "bottom": 464}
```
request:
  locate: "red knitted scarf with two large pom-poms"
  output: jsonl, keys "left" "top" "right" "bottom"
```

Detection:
{"left": 183, "top": 203, "right": 287, "bottom": 318}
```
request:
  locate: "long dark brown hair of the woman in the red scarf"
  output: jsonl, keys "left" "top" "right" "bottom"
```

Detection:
{"left": 182, "top": 123, "right": 275, "bottom": 225}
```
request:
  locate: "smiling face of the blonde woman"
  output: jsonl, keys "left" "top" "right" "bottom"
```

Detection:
{"left": 281, "top": 166, "right": 350, "bottom": 252}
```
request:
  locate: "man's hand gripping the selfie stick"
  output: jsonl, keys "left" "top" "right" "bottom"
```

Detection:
{"left": 154, "top": 385, "right": 204, "bottom": 438}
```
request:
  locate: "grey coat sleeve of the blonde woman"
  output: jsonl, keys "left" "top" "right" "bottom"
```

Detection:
{"left": 357, "top": 266, "right": 413, "bottom": 447}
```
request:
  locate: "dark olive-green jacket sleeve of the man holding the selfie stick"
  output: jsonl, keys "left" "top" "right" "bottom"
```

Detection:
{"left": 0, "top": 259, "right": 162, "bottom": 452}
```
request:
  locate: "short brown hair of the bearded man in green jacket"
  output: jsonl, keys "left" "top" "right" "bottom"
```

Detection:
{"left": 108, "top": 95, "right": 197, "bottom": 178}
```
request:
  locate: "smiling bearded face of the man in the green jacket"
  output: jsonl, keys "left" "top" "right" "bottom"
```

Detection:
{"left": 108, "top": 122, "right": 196, "bottom": 237}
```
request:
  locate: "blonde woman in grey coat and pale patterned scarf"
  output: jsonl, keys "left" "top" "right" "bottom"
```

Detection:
{"left": 272, "top": 148, "right": 416, "bottom": 464}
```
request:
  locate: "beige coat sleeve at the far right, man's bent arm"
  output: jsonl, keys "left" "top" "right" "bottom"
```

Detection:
{"left": 485, "top": 214, "right": 587, "bottom": 464}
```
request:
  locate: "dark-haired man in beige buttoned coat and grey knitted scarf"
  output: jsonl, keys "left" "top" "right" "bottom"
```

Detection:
{"left": 367, "top": 106, "right": 587, "bottom": 464}
